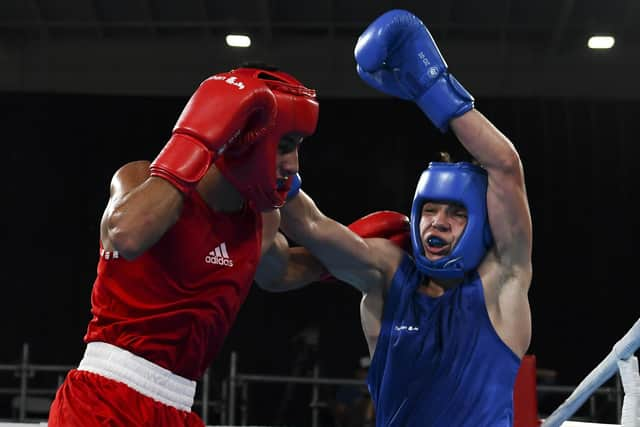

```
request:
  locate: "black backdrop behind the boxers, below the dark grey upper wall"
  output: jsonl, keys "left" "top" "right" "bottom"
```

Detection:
{"left": 0, "top": 93, "right": 640, "bottom": 422}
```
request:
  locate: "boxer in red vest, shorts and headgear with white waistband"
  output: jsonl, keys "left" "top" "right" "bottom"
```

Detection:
{"left": 48, "top": 67, "right": 322, "bottom": 427}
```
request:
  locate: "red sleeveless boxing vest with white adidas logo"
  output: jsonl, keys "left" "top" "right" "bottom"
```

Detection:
{"left": 84, "top": 191, "right": 262, "bottom": 380}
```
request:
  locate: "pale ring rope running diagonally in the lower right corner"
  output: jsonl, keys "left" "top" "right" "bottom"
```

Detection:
{"left": 541, "top": 319, "right": 640, "bottom": 427}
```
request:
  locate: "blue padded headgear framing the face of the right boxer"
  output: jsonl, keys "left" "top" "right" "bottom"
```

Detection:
{"left": 411, "top": 162, "right": 493, "bottom": 279}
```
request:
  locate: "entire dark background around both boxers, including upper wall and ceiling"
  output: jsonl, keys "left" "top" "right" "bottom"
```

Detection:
{"left": 0, "top": 0, "right": 640, "bottom": 425}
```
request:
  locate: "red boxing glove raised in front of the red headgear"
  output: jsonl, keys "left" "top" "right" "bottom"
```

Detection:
{"left": 149, "top": 73, "right": 277, "bottom": 193}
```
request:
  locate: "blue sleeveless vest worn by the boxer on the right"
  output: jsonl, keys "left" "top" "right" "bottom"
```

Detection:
{"left": 367, "top": 255, "right": 520, "bottom": 427}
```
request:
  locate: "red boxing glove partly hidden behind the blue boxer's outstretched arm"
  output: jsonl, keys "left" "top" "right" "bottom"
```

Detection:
{"left": 320, "top": 211, "right": 411, "bottom": 281}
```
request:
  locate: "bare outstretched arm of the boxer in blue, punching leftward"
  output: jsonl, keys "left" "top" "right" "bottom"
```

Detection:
{"left": 280, "top": 191, "right": 403, "bottom": 293}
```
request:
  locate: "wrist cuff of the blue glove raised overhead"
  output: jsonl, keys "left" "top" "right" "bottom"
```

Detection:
{"left": 416, "top": 73, "right": 474, "bottom": 132}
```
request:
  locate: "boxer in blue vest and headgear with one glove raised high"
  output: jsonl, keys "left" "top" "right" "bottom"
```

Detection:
{"left": 281, "top": 10, "right": 532, "bottom": 427}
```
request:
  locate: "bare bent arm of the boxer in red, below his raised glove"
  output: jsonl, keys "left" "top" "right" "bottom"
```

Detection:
{"left": 100, "top": 161, "right": 183, "bottom": 260}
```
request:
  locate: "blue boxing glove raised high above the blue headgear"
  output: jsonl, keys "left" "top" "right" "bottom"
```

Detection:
{"left": 355, "top": 9, "right": 474, "bottom": 132}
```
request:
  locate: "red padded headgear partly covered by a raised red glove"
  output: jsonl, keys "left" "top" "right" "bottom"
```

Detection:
{"left": 215, "top": 68, "right": 319, "bottom": 211}
